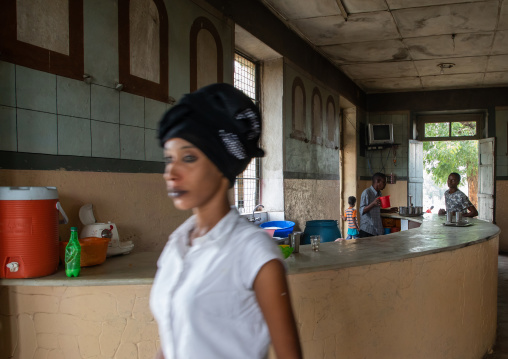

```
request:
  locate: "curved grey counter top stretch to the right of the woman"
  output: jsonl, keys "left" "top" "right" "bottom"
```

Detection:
{"left": 286, "top": 214, "right": 500, "bottom": 274}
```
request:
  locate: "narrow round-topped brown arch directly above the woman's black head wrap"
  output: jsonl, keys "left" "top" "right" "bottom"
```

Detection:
{"left": 190, "top": 17, "right": 224, "bottom": 92}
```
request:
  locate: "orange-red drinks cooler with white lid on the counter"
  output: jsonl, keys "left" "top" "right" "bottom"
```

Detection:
{"left": 0, "top": 187, "right": 68, "bottom": 278}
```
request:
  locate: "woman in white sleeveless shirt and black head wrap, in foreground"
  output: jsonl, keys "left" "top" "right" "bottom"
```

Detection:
{"left": 150, "top": 84, "right": 302, "bottom": 359}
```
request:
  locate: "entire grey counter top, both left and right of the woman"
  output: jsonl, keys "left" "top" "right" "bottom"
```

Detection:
{"left": 0, "top": 214, "right": 500, "bottom": 286}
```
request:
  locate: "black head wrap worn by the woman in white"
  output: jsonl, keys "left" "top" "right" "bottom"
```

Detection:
{"left": 158, "top": 84, "right": 264, "bottom": 185}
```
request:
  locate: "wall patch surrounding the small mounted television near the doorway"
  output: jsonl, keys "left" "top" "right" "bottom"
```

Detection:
{"left": 358, "top": 112, "right": 409, "bottom": 177}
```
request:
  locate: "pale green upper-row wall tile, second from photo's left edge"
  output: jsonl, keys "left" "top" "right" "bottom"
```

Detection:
{"left": 16, "top": 66, "right": 56, "bottom": 113}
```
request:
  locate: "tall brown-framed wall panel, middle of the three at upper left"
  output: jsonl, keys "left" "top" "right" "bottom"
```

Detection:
{"left": 118, "top": 0, "right": 169, "bottom": 102}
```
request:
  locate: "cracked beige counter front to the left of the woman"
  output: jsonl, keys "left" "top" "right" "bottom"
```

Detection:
{"left": 0, "top": 285, "right": 160, "bottom": 359}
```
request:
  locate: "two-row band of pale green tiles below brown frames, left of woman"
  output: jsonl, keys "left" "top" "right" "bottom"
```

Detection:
{"left": 0, "top": 61, "right": 169, "bottom": 161}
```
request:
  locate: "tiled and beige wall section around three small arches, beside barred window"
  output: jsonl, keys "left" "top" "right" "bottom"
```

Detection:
{"left": 284, "top": 62, "right": 341, "bottom": 231}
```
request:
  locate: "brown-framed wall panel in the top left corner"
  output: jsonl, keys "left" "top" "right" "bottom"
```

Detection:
{"left": 0, "top": 0, "right": 84, "bottom": 80}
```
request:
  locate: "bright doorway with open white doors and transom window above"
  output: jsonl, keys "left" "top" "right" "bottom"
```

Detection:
{"left": 408, "top": 111, "right": 496, "bottom": 222}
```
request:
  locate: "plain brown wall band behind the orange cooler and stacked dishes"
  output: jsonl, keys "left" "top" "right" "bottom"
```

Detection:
{"left": 0, "top": 170, "right": 190, "bottom": 252}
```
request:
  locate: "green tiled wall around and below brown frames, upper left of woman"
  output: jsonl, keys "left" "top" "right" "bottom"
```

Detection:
{"left": 0, "top": 0, "right": 234, "bottom": 171}
